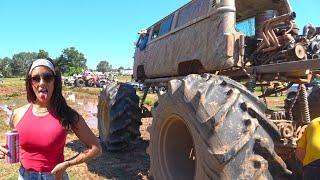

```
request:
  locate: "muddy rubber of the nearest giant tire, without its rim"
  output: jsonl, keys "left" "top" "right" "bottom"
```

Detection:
{"left": 148, "top": 75, "right": 287, "bottom": 179}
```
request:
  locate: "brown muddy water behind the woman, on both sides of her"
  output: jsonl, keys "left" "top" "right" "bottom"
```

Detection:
{"left": 0, "top": 91, "right": 98, "bottom": 129}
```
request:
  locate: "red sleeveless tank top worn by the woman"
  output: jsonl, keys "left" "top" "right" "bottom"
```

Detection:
{"left": 16, "top": 104, "right": 67, "bottom": 172}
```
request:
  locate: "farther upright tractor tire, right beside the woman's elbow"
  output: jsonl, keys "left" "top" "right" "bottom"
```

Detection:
{"left": 98, "top": 83, "right": 141, "bottom": 151}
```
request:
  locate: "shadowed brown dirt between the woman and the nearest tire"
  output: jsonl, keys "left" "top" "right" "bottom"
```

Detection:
{"left": 65, "top": 118, "right": 152, "bottom": 180}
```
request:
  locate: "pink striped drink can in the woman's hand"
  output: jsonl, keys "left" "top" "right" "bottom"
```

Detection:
{"left": 5, "top": 130, "right": 20, "bottom": 164}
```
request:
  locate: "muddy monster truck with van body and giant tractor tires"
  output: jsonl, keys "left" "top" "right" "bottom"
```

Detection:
{"left": 98, "top": 0, "right": 320, "bottom": 180}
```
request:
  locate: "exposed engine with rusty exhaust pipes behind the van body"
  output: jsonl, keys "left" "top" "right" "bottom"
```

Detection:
{"left": 246, "top": 12, "right": 320, "bottom": 66}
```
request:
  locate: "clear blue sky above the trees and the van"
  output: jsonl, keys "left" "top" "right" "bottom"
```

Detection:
{"left": 0, "top": 0, "right": 320, "bottom": 69}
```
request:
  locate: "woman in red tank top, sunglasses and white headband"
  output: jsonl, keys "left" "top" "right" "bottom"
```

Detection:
{"left": 0, "top": 59, "right": 101, "bottom": 179}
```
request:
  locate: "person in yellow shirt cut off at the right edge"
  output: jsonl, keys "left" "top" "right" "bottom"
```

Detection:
{"left": 296, "top": 117, "right": 320, "bottom": 180}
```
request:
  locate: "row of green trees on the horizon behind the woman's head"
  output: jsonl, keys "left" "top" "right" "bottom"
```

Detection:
{"left": 0, "top": 47, "right": 117, "bottom": 77}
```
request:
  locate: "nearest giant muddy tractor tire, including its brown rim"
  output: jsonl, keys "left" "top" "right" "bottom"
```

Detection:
{"left": 147, "top": 74, "right": 290, "bottom": 180}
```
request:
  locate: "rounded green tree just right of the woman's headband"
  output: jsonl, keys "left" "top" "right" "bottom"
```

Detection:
{"left": 55, "top": 47, "right": 87, "bottom": 75}
